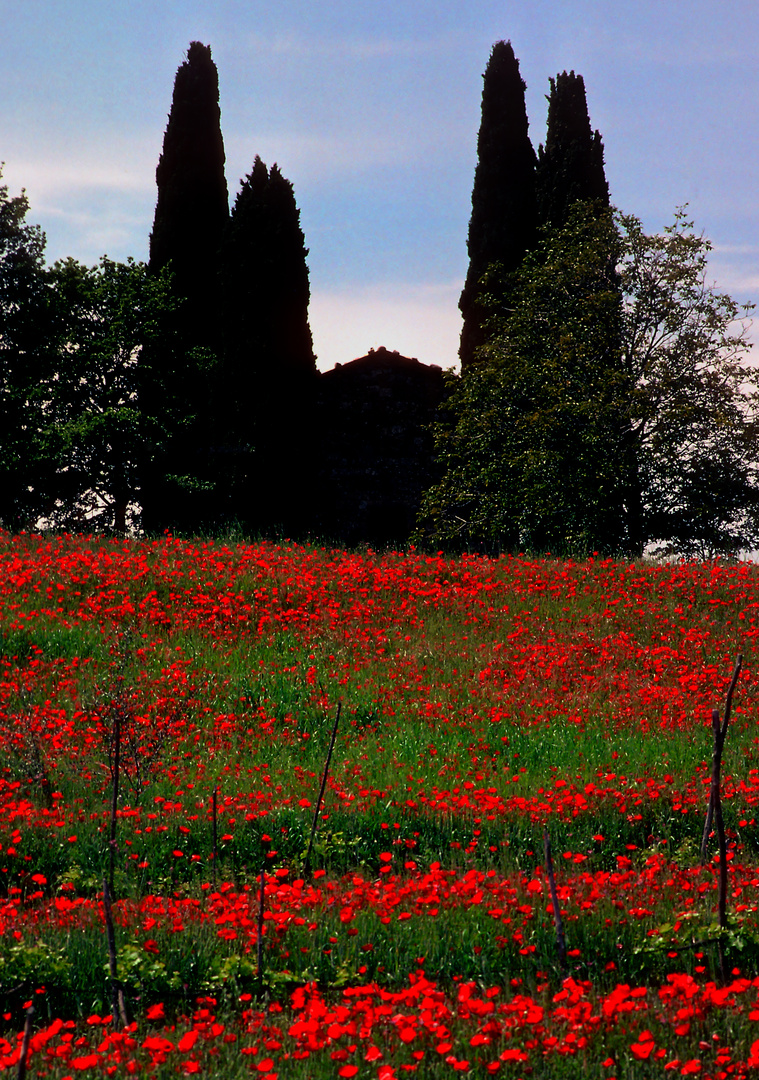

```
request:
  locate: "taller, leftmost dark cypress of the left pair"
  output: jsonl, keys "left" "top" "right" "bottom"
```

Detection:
{"left": 140, "top": 41, "right": 229, "bottom": 530}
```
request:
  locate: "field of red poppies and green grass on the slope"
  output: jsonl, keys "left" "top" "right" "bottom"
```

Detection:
{"left": 0, "top": 532, "right": 759, "bottom": 1080}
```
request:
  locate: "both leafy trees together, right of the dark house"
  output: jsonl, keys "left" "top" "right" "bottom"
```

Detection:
{"left": 418, "top": 203, "right": 759, "bottom": 557}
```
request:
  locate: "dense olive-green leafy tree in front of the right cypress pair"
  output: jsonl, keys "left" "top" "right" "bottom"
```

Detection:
{"left": 420, "top": 204, "right": 634, "bottom": 554}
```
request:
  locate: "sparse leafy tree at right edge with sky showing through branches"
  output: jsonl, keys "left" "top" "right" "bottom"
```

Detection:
{"left": 616, "top": 210, "right": 759, "bottom": 557}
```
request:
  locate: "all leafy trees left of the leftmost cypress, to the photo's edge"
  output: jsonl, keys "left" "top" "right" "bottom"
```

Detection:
{"left": 0, "top": 177, "right": 179, "bottom": 531}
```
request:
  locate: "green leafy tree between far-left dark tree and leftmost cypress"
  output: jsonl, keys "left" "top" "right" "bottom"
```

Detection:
{"left": 39, "top": 256, "right": 175, "bottom": 532}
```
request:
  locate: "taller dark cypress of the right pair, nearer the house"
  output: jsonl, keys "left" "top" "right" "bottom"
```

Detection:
{"left": 459, "top": 41, "right": 537, "bottom": 369}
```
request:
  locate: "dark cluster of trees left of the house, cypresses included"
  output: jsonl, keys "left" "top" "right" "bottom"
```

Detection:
{"left": 0, "top": 42, "right": 316, "bottom": 532}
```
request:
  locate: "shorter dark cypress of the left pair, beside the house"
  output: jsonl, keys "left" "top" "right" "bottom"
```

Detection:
{"left": 217, "top": 157, "right": 316, "bottom": 531}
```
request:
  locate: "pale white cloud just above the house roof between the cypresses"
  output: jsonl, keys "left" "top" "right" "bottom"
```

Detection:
{"left": 309, "top": 282, "right": 462, "bottom": 372}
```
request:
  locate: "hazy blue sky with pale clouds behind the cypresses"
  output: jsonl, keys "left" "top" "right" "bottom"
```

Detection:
{"left": 0, "top": 0, "right": 759, "bottom": 368}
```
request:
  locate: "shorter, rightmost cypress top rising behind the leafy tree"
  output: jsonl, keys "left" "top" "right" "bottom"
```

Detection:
{"left": 537, "top": 71, "right": 609, "bottom": 228}
